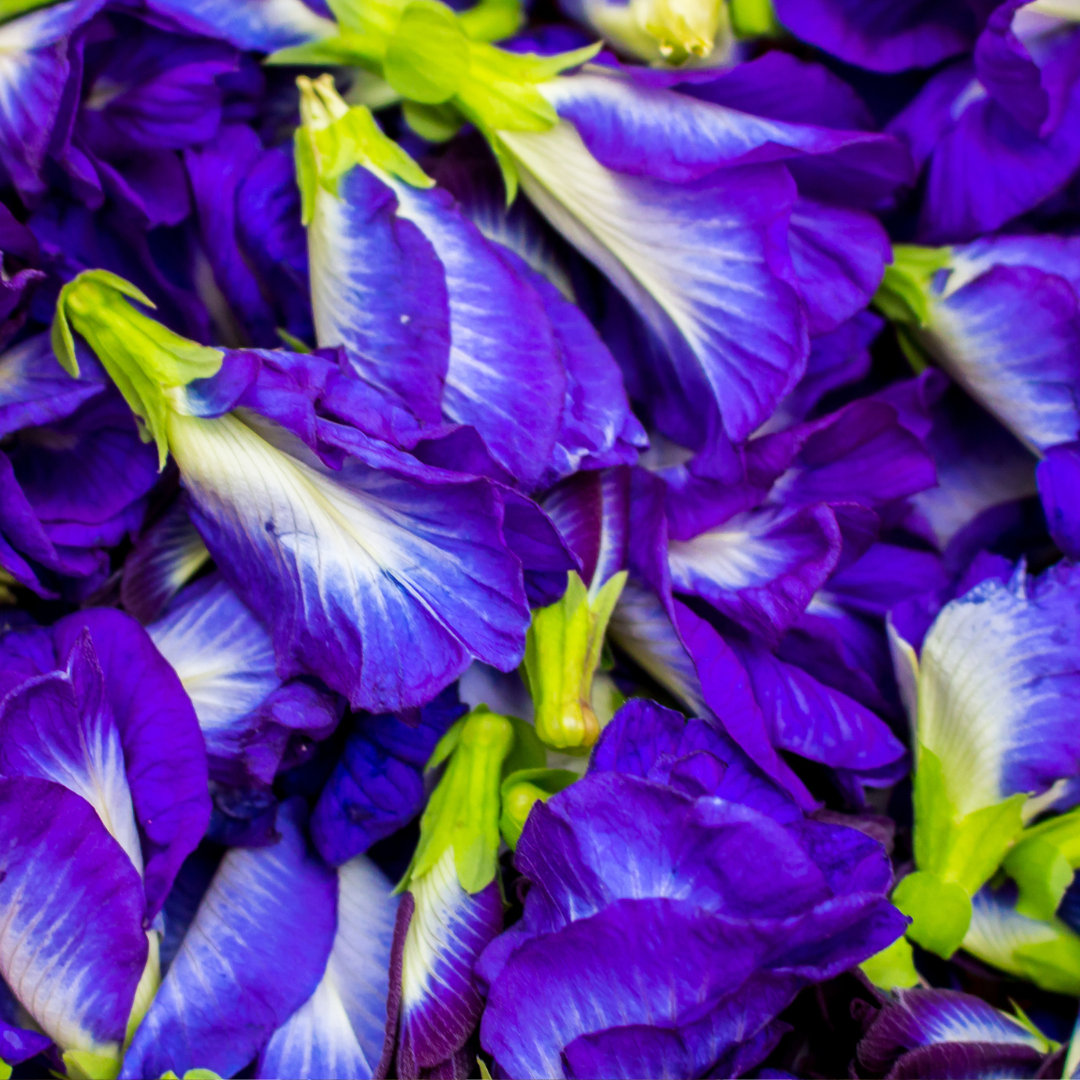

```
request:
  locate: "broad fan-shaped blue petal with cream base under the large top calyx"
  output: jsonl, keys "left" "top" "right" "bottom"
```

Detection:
{"left": 502, "top": 123, "right": 807, "bottom": 451}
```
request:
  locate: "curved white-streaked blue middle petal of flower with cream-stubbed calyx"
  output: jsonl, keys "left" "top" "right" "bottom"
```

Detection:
{"left": 394, "top": 183, "right": 567, "bottom": 487}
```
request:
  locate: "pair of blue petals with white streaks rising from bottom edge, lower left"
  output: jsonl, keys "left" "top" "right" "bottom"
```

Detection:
{"left": 121, "top": 798, "right": 396, "bottom": 1078}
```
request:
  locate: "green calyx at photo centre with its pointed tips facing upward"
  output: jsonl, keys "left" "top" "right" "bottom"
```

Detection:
{"left": 524, "top": 570, "right": 626, "bottom": 751}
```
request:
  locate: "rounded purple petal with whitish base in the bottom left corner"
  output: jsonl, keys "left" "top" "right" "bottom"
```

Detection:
{"left": 0, "top": 778, "right": 147, "bottom": 1056}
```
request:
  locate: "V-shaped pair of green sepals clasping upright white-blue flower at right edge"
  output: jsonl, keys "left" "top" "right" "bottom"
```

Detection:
{"left": 914, "top": 743, "right": 1027, "bottom": 896}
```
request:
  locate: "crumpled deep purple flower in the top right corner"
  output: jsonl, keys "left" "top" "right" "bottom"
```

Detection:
{"left": 889, "top": 0, "right": 1080, "bottom": 244}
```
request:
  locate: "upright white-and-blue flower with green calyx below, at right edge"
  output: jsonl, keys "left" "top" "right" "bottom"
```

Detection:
{"left": 892, "top": 565, "right": 1080, "bottom": 957}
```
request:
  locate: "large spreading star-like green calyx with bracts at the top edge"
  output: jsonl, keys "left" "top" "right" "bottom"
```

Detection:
{"left": 268, "top": 0, "right": 600, "bottom": 197}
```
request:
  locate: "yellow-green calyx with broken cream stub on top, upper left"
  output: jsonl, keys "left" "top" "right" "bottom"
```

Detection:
{"left": 295, "top": 75, "right": 435, "bottom": 225}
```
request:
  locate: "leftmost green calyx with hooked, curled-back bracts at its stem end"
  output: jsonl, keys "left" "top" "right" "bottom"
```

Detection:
{"left": 52, "top": 270, "right": 225, "bottom": 468}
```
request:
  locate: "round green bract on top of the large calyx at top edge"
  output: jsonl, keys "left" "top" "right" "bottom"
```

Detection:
{"left": 382, "top": 0, "right": 470, "bottom": 105}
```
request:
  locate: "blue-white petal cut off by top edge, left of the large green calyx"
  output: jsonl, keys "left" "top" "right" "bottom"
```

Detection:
{"left": 148, "top": 0, "right": 337, "bottom": 53}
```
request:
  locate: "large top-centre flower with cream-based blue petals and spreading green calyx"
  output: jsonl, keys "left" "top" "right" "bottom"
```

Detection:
{"left": 272, "top": 4, "right": 908, "bottom": 462}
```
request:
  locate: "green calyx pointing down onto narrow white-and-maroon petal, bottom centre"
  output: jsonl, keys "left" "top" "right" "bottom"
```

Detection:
{"left": 397, "top": 705, "right": 514, "bottom": 893}
